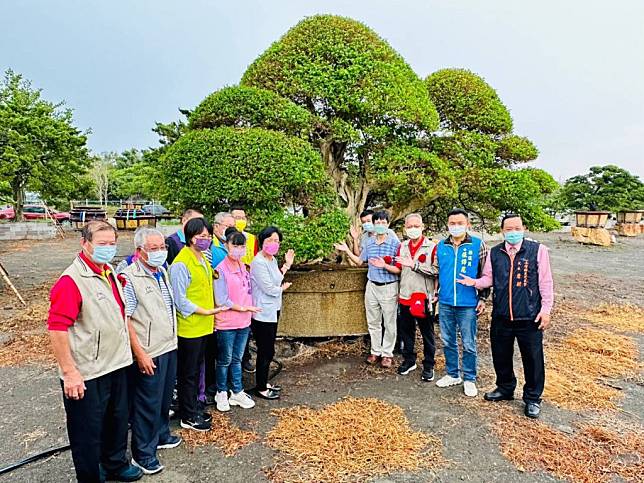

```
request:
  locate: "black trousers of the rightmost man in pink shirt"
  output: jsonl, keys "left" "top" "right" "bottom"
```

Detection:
{"left": 490, "top": 318, "right": 546, "bottom": 402}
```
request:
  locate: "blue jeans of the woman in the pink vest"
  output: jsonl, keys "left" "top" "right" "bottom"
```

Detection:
{"left": 216, "top": 327, "right": 250, "bottom": 393}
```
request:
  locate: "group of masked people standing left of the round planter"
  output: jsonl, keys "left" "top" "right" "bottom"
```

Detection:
{"left": 48, "top": 207, "right": 295, "bottom": 482}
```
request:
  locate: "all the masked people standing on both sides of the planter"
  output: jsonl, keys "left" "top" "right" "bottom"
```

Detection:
{"left": 48, "top": 207, "right": 553, "bottom": 482}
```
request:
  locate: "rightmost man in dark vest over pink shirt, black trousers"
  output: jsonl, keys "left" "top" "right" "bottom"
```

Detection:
{"left": 459, "top": 214, "right": 554, "bottom": 418}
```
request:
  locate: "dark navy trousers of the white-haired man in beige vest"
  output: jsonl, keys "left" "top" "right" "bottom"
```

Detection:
{"left": 129, "top": 350, "right": 177, "bottom": 465}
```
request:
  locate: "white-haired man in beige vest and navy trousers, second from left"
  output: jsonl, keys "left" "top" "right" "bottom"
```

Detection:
{"left": 123, "top": 227, "right": 181, "bottom": 475}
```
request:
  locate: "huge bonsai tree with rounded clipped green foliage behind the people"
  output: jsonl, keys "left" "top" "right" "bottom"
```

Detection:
{"left": 157, "top": 15, "right": 554, "bottom": 258}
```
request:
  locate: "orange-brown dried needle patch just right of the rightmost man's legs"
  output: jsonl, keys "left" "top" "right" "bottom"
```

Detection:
{"left": 544, "top": 328, "right": 639, "bottom": 410}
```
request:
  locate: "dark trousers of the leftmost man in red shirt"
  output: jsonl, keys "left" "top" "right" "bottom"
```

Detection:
{"left": 61, "top": 368, "right": 129, "bottom": 483}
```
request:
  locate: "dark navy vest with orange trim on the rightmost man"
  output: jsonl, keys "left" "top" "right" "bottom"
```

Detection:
{"left": 490, "top": 239, "right": 541, "bottom": 320}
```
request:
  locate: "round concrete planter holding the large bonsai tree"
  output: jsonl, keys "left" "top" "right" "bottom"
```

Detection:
{"left": 277, "top": 265, "right": 367, "bottom": 337}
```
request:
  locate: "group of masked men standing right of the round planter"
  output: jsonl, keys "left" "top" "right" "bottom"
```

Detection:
{"left": 336, "top": 209, "right": 554, "bottom": 412}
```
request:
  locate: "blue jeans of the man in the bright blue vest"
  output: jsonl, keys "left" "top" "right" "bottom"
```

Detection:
{"left": 438, "top": 304, "right": 476, "bottom": 381}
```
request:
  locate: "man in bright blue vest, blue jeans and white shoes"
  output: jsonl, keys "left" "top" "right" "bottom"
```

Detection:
{"left": 434, "top": 209, "right": 489, "bottom": 397}
